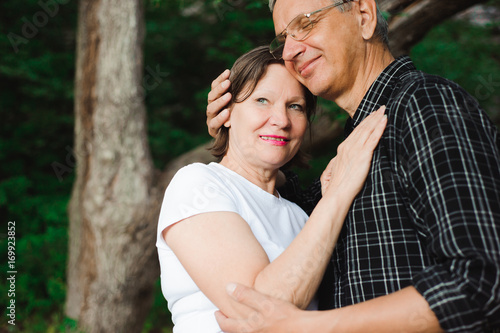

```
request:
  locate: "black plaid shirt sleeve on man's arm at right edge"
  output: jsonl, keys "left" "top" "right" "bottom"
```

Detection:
{"left": 395, "top": 79, "right": 500, "bottom": 332}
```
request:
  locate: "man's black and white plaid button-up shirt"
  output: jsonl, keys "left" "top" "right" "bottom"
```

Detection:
{"left": 280, "top": 57, "right": 500, "bottom": 332}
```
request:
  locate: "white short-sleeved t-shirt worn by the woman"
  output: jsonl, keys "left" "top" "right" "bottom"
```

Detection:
{"left": 156, "top": 163, "right": 308, "bottom": 333}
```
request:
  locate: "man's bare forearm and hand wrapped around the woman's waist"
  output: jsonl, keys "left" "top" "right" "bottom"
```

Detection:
{"left": 216, "top": 285, "right": 443, "bottom": 333}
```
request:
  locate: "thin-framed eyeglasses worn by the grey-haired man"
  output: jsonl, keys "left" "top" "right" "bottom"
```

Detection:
{"left": 269, "top": 0, "right": 354, "bottom": 59}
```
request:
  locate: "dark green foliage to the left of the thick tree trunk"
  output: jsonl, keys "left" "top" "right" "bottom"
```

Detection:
{"left": 0, "top": 0, "right": 76, "bottom": 332}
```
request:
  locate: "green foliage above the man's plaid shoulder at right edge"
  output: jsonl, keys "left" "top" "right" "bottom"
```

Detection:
{"left": 412, "top": 20, "right": 500, "bottom": 117}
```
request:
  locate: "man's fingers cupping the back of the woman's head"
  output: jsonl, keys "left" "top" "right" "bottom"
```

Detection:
{"left": 207, "top": 69, "right": 231, "bottom": 137}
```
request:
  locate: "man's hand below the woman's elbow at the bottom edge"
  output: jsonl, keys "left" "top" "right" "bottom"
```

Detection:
{"left": 215, "top": 284, "right": 306, "bottom": 333}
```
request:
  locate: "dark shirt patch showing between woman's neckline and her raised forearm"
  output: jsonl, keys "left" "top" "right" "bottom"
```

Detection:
{"left": 278, "top": 170, "right": 321, "bottom": 215}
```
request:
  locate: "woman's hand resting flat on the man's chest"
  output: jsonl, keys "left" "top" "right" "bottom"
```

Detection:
{"left": 320, "top": 106, "right": 387, "bottom": 201}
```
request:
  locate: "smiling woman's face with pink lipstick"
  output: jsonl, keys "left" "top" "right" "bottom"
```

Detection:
{"left": 225, "top": 64, "right": 307, "bottom": 170}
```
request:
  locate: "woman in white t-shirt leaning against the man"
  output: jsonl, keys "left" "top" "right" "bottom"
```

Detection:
{"left": 157, "top": 47, "right": 386, "bottom": 333}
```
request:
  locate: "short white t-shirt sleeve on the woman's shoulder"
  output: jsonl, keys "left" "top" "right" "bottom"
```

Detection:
{"left": 157, "top": 163, "right": 238, "bottom": 247}
